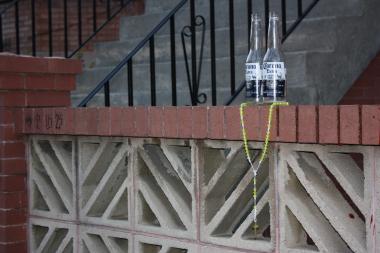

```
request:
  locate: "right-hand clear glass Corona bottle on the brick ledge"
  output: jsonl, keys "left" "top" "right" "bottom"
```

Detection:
{"left": 263, "top": 13, "right": 287, "bottom": 103}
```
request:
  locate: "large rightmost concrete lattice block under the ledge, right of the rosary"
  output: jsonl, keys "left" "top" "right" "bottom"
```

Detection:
{"left": 276, "top": 144, "right": 373, "bottom": 253}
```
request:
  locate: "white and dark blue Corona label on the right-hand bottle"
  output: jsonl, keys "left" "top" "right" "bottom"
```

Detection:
{"left": 263, "top": 62, "right": 286, "bottom": 98}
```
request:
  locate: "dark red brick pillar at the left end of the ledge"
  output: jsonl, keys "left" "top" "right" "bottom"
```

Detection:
{"left": 0, "top": 55, "right": 81, "bottom": 252}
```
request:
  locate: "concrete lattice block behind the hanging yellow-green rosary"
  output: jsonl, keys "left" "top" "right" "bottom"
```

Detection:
{"left": 196, "top": 141, "right": 274, "bottom": 252}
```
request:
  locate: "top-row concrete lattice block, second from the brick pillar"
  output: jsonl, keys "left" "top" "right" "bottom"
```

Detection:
{"left": 78, "top": 137, "right": 132, "bottom": 228}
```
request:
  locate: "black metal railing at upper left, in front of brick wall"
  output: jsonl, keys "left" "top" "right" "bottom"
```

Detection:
{"left": 0, "top": 0, "right": 133, "bottom": 58}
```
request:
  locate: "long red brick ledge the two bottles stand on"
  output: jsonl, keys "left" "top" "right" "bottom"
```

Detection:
{"left": 17, "top": 105, "right": 380, "bottom": 145}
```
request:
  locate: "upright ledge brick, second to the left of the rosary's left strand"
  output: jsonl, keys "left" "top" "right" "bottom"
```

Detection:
{"left": 207, "top": 106, "right": 224, "bottom": 140}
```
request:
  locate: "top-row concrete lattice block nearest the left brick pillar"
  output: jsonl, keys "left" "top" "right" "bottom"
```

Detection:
{"left": 28, "top": 136, "right": 76, "bottom": 220}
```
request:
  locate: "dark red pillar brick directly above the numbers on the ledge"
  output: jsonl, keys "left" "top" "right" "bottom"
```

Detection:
{"left": 26, "top": 91, "right": 71, "bottom": 107}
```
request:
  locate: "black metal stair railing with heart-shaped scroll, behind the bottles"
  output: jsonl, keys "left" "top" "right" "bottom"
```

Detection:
{"left": 79, "top": 0, "right": 319, "bottom": 106}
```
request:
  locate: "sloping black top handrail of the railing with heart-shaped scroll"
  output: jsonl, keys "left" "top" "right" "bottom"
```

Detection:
{"left": 78, "top": 0, "right": 188, "bottom": 107}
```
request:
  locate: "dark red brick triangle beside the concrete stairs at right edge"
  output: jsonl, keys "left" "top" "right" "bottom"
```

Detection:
{"left": 339, "top": 54, "right": 380, "bottom": 105}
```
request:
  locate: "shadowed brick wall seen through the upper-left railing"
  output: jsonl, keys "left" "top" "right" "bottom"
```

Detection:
{"left": 3, "top": 0, "right": 144, "bottom": 56}
